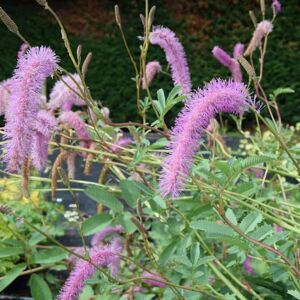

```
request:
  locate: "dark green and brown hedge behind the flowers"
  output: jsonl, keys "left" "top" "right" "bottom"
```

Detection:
{"left": 0, "top": 0, "right": 300, "bottom": 123}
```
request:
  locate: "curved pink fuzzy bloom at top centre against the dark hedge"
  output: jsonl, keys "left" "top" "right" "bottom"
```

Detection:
{"left": 149, "top": 26, "right": 192, "bottom": 94}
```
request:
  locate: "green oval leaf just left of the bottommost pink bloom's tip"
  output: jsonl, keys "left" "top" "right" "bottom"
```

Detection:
{"left": 32, "top": 247, "right": 69, "bottom": 264}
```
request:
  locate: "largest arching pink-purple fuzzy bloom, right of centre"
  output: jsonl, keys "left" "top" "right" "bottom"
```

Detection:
{"left": 159, "top": 79, "right": 249, "bottom": 198}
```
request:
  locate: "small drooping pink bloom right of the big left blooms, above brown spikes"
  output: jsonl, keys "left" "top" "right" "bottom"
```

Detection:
{"left": 59, "top": 111, "right": 91, "bottom": 148}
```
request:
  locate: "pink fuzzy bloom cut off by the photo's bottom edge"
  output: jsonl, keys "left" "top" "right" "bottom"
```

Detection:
{"left": 57, "top": 243, "right": 122, "bottom": 300}
